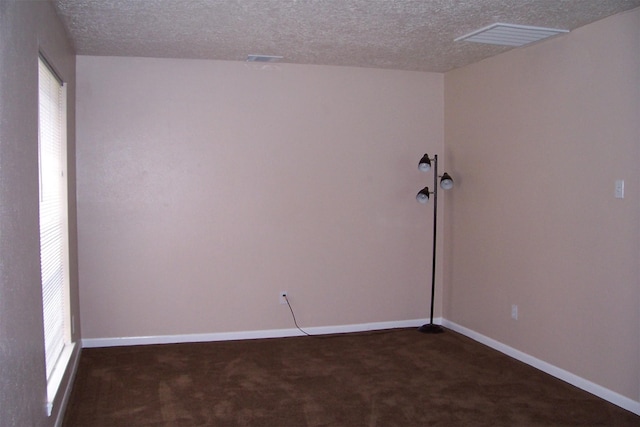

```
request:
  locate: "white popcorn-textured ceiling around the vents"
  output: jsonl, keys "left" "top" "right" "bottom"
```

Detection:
{"left": 51, "top": 0, "right": 640, "bottom": 72}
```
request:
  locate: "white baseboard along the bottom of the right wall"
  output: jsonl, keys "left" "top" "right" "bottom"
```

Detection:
{"left": 442, "top": 319, "right": 640, "bottom": 415}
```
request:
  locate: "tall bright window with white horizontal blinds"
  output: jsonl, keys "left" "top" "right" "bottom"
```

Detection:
{"left": 38, "top": 58, "right": 73, "bottom": 415}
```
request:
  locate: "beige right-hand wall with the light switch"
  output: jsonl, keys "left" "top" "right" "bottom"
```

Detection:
{"left": 443, "top": 9, "right": 640, "bottom": 401}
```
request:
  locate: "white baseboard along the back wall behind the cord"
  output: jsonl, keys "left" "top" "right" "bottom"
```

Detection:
{"left": 82, "top": 319, "right": 430, "bottom": 348}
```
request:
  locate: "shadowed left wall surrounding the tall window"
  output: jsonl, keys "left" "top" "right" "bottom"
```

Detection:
{"left": 0, "top": 0, "right": 80, "bottom": 426}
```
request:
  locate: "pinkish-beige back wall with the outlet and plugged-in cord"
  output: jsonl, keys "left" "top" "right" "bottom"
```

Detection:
{"left": 77, "top": 56, "right": 444, "bottom": 339}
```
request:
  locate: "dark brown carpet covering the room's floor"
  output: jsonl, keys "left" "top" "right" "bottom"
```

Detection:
{"left": 63, "top": 329, "right": 640, "bottom": 427}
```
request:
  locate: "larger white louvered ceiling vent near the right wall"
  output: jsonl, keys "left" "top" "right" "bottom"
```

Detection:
{"left": 455, "top": 24, "right": 569, "bottom": 46}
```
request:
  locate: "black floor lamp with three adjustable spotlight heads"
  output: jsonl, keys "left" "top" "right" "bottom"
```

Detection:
{"left": 416, "top": 154, "right": 453, "bottom": 334}
